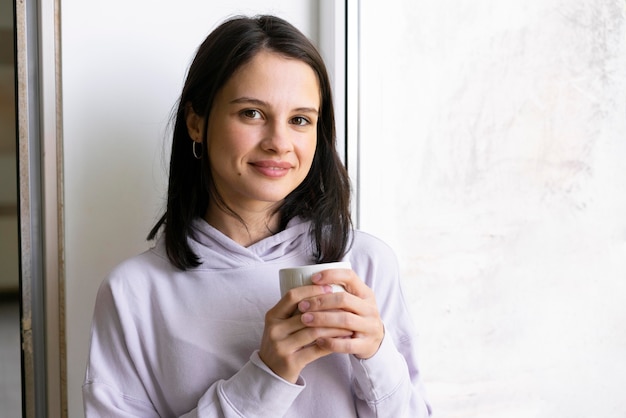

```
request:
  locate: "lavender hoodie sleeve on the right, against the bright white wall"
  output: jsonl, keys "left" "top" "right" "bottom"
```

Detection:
{"left": 350, "top": 232, "right": 431, "bottom": 418}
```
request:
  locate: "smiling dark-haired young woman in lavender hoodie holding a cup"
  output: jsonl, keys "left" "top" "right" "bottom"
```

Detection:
{"left": 83, "top": 16, "right": 430, "bottom": 418}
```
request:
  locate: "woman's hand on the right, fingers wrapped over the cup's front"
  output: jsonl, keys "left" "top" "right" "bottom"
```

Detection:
{"left": 298, "top": 269, "right": 385, "bottom": 359}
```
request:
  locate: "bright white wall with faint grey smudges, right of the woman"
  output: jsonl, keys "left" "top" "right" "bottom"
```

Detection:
{"left": 359, "top": 0, "right": 626, "bottom": 418}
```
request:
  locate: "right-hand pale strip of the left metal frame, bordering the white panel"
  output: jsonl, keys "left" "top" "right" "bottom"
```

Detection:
{"left": 39, "top": 0, "right": 67, "bottom": 417}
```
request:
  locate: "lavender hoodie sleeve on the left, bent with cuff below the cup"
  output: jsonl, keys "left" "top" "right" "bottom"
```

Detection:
{"left": 83, "top": 274, "right": 305, "bottom": 418}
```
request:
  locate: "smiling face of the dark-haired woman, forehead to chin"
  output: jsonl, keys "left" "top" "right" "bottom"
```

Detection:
{"left": 192, "top": 51, "right": 320, "bottom": 212}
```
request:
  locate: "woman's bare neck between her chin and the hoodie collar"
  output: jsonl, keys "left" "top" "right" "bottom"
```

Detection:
{"left": 204, "top": 202, "right": 280, "bottom": 247}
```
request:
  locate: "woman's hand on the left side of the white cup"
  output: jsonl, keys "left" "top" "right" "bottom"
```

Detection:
{"left": 259, "top": 285, "right": 352, "bottom": 383}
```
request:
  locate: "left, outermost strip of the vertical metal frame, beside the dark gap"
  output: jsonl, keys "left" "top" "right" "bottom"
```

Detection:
{"left": 15, "top": 0, "right": 46, "bottom": 418}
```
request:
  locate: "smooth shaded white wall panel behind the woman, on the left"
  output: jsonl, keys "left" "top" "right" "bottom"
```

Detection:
{"left": 61, "top": 0, "right": 317, "bottom": 418}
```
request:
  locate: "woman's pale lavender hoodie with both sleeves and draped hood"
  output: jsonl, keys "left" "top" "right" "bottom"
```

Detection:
{"left": 83, "top": 219, "right": 430, "bottom": 418}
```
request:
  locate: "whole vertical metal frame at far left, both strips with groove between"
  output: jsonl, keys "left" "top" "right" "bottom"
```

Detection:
{"left": 15, "top": 0, "right": 67, "bottom": 418}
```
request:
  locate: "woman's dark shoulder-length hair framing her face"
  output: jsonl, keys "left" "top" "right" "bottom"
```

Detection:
{"left": 148, "top": 16, "right": 352, "bottom": 270}
